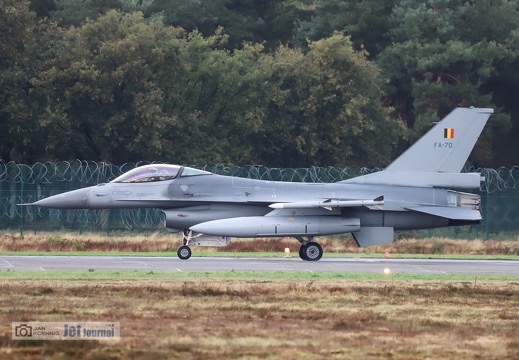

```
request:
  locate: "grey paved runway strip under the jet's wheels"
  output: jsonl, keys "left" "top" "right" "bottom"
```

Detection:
{"left": 0, "top": 255, "right": 519, "bottom": 276}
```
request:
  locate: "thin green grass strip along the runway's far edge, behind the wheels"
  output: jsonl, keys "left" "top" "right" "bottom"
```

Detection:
{"left": 0, "top": 251, "right": 519, "bottom": 260}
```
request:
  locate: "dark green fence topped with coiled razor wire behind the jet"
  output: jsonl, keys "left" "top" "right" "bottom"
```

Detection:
{"left": 0, "top": 160, "right": 519, "bottom": 238}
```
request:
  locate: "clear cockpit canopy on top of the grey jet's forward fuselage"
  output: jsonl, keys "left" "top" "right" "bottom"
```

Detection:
{"left": 110, "top": 164, "right": 211, "bottom": 183}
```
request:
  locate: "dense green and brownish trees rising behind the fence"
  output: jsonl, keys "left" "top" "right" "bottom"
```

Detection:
{"left": 0, "top": 0, "right": 519, "bottom": 168}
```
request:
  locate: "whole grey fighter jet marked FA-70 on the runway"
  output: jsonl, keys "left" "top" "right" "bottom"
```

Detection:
{"left": 32, "top": 108, "right": 493, "bottom": 261}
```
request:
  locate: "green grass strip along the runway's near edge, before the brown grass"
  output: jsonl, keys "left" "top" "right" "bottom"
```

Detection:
{"left": 0, "top": 269, "right": 519, "bottom": 283}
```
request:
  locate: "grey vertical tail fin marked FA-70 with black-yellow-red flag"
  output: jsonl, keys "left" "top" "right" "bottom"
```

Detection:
{"left": 386, "top": 108, "right": 494, "bottom": 173}
